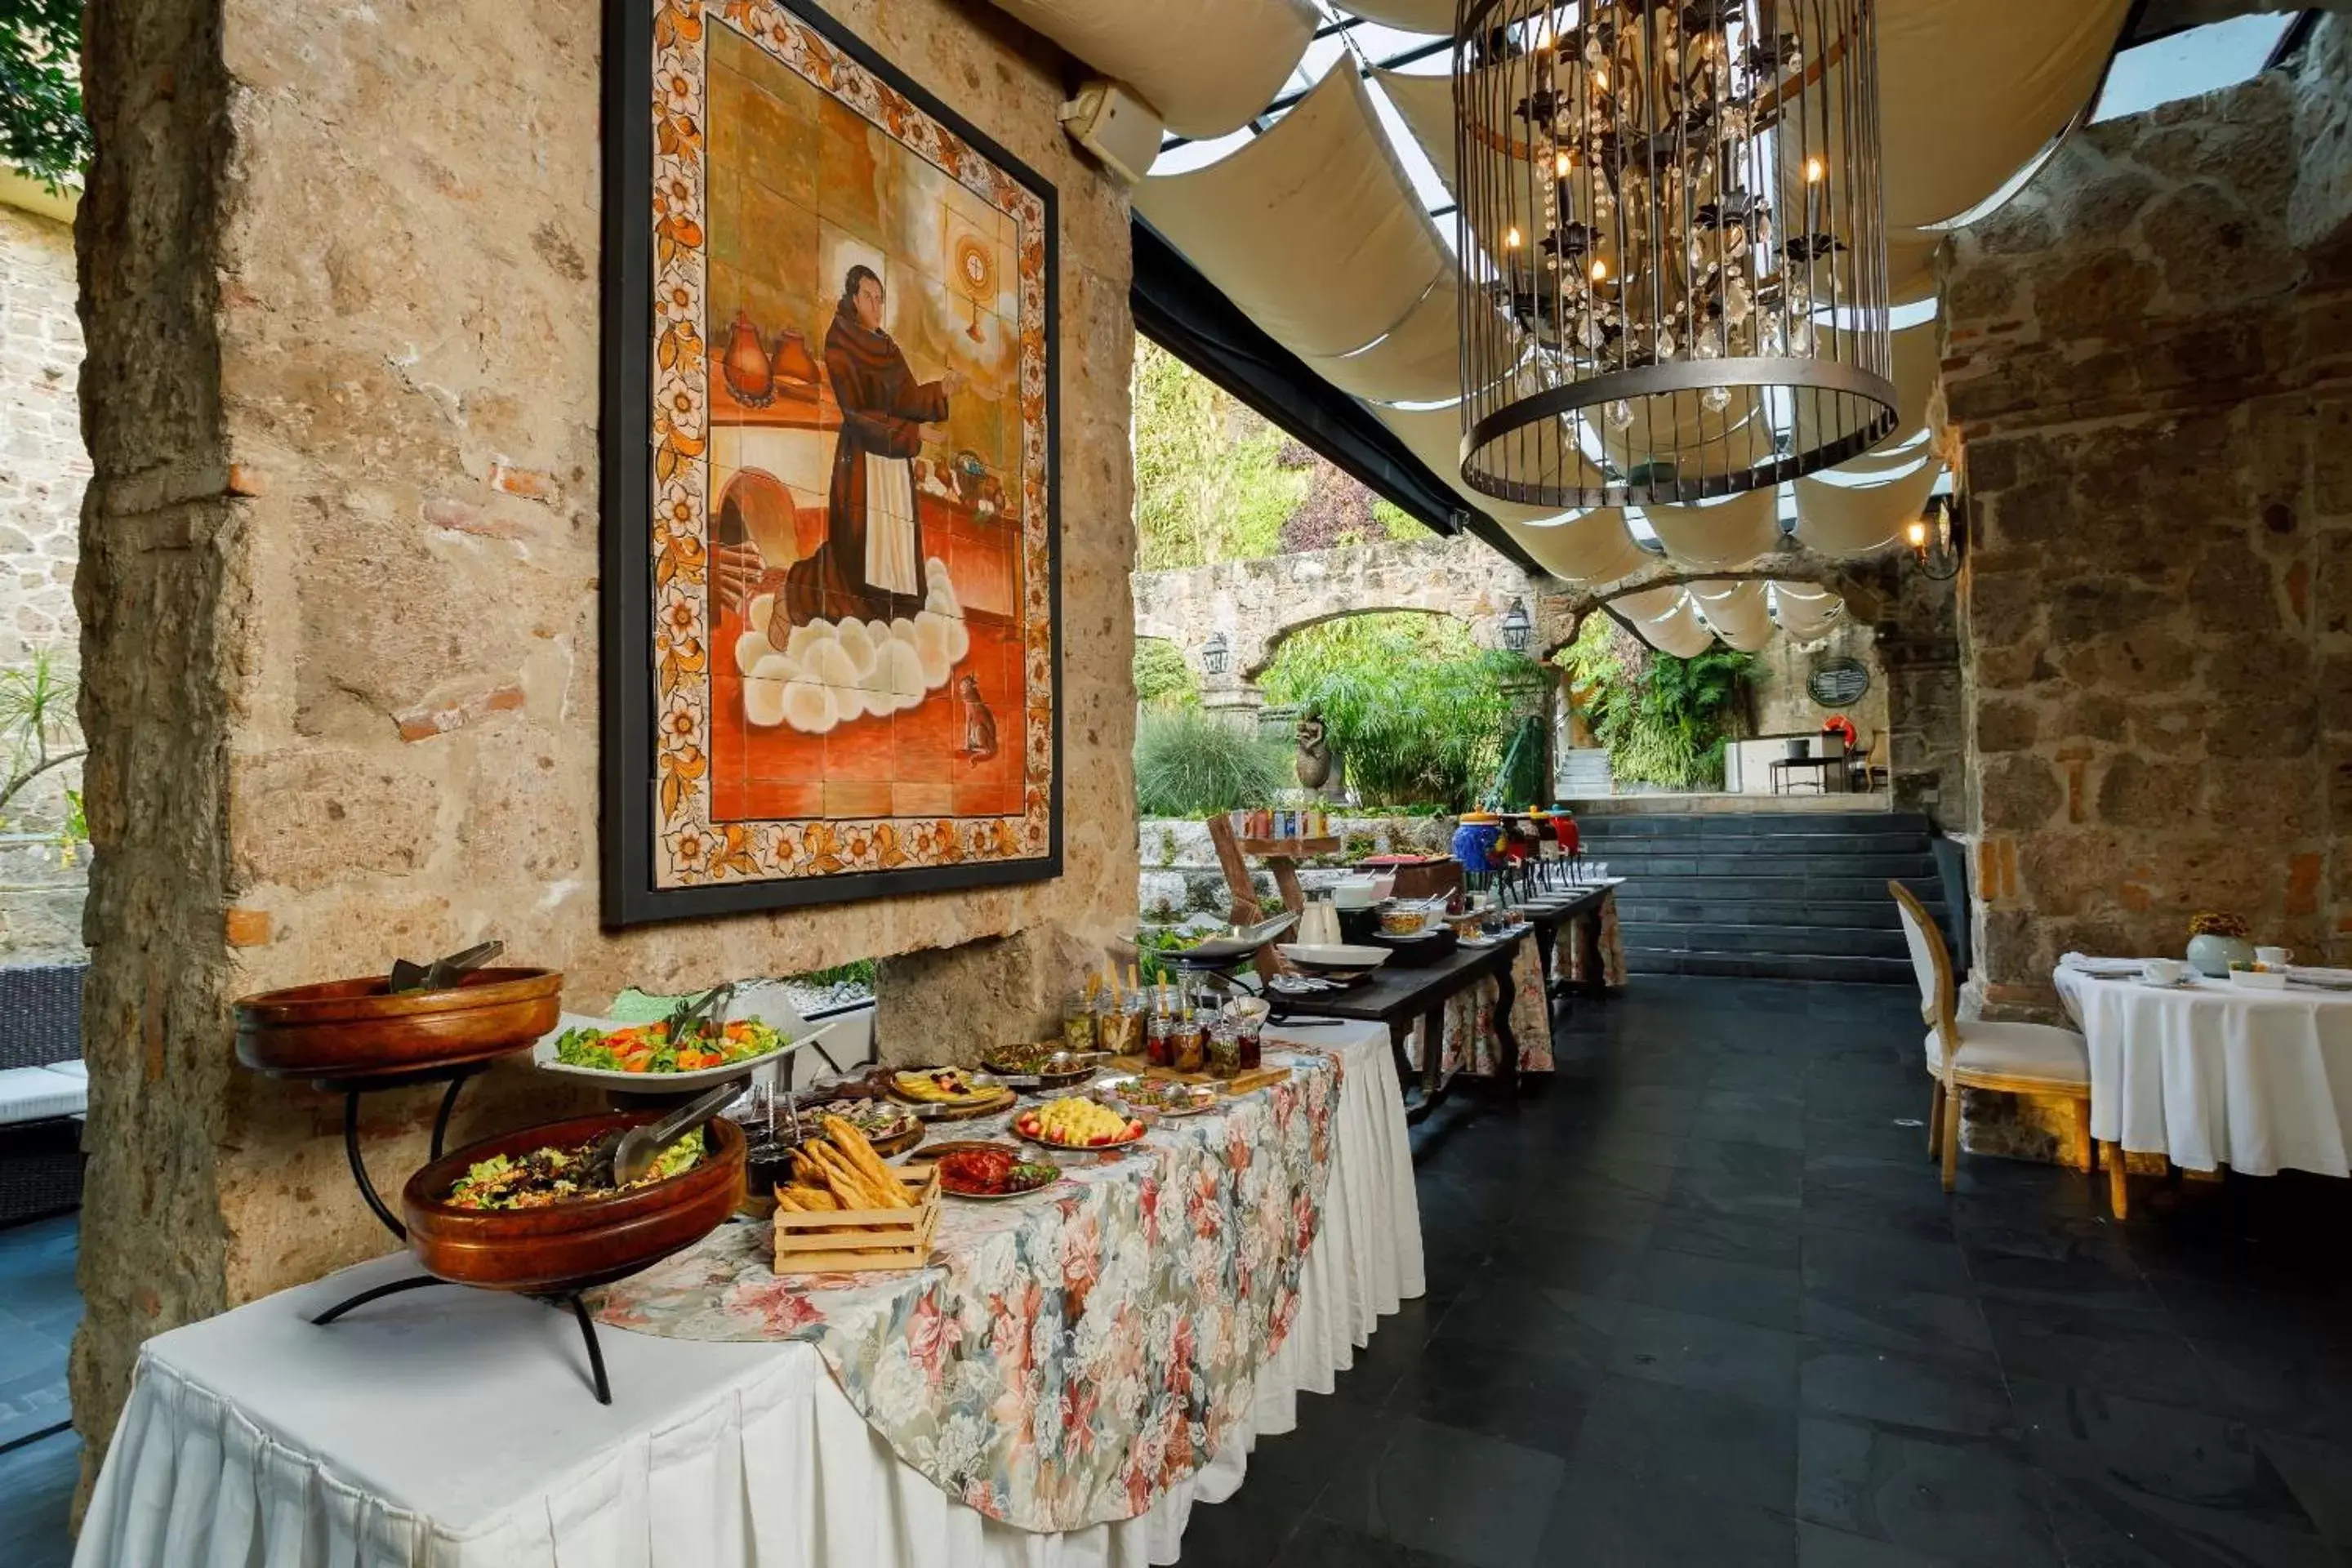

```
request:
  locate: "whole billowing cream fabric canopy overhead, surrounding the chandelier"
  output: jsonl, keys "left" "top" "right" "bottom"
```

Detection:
{"left": 1100, "top": 0, "right": 2131, "bottom": 647}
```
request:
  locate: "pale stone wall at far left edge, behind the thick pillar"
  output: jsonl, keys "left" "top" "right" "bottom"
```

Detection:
{"left": 0, "top": 202, "right": 89, "bottom": 964}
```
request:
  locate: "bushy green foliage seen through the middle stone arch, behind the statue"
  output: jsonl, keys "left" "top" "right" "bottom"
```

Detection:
{"left": 1261, "top": 611, "right": 1543, "bottom": 811}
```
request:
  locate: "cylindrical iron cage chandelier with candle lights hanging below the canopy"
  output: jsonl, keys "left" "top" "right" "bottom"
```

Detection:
{"left": 1454, "top": 0, "right": 1895, "bottom": 508}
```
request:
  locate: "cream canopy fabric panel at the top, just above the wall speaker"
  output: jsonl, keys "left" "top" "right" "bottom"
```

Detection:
{"left": 978, "top": 0, "right": 1316, "bottom": 136}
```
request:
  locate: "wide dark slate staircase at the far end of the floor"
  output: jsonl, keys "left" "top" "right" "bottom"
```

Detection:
{"left": 1578, "top": 808, "right": 1957, "bottom": 985}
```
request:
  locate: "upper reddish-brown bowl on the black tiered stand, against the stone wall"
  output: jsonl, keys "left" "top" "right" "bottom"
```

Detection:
{"left": 238, "top": 969, "right": 564, "bottom": 1079}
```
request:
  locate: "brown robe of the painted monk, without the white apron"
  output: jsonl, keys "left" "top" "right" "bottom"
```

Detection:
{"left": 783, "top": 301, "right": 948, "bottom": 626}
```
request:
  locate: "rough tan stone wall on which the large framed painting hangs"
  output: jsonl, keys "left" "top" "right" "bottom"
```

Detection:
{"left": 73, "top": 0, "right": 1136, "bottom": 1462}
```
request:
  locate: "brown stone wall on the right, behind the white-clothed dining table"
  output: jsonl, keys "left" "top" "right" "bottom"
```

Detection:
{"left": 1945, "top": 16, "right": 2352, "bottom": 1016}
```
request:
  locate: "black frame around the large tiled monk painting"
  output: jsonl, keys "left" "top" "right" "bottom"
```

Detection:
{"left": 598, "top": 0, "right": 1063, "bottom": 929}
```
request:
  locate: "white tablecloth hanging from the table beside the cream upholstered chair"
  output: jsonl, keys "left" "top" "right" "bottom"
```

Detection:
{"left": 2058, "top": 966, "right": 2352, "bottom": 1175}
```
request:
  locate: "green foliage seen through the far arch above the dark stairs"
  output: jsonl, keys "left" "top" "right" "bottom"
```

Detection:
{"left": 1559, "top": 616, "right": 1754, "bottom": 790}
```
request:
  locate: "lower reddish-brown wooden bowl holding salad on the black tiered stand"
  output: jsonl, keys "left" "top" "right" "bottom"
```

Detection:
{"left": 400, "top": 1112, "right": 743, "bottom": 1295}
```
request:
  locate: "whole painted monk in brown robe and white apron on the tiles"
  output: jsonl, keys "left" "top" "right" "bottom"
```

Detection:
{"left": 783, "top": 265, "right": 964, "bottom": 626}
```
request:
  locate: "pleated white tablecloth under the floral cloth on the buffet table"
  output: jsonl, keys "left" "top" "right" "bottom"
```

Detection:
{"left": 73, "top": 1025, "right": 1423, "bottom": 1568}
